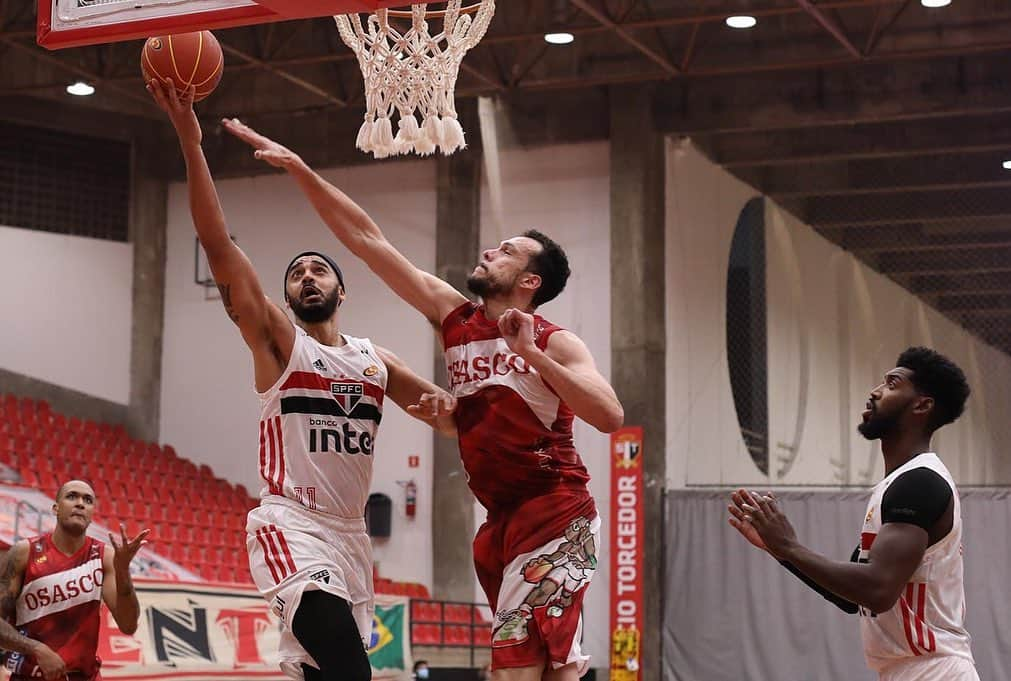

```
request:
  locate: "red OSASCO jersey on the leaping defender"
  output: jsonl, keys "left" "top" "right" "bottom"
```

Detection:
{"left": 442, "top": 302, "right": 589, "bottom": 513}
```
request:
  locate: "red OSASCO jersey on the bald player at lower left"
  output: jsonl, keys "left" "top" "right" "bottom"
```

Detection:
{"left": 5, "top": 534, "right": 105, "bottom": 681}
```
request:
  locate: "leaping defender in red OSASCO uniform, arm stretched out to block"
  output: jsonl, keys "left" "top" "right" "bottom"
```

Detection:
{"left": 225, "top": 120, "right": 624, "bottom": 681}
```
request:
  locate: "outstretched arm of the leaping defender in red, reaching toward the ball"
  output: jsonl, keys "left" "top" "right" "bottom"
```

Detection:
{"left": 222, "top": 119, "right": 467, "bottom": 327}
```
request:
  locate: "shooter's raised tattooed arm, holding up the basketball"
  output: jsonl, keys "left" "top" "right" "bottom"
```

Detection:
{"left": 148, "top": 80, "right": 295, "bottom": 390}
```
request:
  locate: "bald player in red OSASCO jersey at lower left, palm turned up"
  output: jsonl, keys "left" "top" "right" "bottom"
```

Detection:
{"left": 0, "top": 480, "right": 150, "bottom": 681}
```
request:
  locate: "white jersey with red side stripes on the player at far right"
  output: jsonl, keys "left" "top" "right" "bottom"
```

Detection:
{"left": 860, "top": 453, "right": 973, "bottom": 671}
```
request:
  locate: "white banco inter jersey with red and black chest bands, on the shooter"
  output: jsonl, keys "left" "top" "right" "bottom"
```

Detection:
{"left": 260, "top": 326, "right": 387, "bottom": 518}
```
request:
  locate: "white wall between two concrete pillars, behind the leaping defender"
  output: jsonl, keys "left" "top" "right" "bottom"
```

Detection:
{"left": 475, "top": 143, "right": 611, "bottom": 667}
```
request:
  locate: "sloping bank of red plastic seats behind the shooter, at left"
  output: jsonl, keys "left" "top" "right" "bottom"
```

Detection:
{"left": 0, "top": 395, "right": 438, "bottom": 598}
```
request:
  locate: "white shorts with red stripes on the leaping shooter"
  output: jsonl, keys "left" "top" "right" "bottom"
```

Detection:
{"left": 246, "top": 497, "right": 375, "bottom": 681}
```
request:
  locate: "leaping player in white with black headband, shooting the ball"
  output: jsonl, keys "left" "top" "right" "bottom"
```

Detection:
{"left": 148, "top": 81, "right": 455, "bottom": 681}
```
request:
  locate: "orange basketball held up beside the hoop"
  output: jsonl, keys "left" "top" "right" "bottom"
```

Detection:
{"left": 141, "top": 30, "right": 224, "bottom": 102}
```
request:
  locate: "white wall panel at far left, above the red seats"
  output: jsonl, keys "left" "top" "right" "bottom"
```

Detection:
{"left": 0, "top": 226, "right": 133, "bottom": 404}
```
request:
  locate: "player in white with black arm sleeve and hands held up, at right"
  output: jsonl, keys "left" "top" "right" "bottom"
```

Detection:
{"left": 729, "top": 348, "right": 979, "bottom": 681}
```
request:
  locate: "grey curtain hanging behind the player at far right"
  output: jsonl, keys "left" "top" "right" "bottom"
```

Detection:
{"left": 663, "top": 488, "right": 1011, "bottom": 681}
